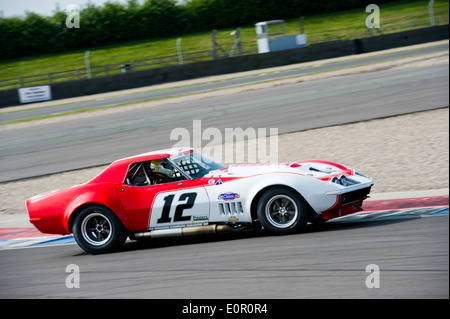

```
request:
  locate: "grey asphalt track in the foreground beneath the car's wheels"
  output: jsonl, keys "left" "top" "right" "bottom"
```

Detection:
{"left": 0, "top": 209, "right": 449, "bottom": 300}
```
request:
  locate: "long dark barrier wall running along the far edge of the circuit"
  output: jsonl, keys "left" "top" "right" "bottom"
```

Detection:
{"left": 0, "top": 25, "right": 449, "bottom": 107}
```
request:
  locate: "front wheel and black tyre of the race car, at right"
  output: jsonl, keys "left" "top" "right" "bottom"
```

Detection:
{"left": 257, "top": 188, "right": 308, "bottom": 235}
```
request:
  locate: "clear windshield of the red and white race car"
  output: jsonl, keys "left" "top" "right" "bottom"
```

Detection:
{"left": 172, "top": 151, "right": 227, "bottom": 179}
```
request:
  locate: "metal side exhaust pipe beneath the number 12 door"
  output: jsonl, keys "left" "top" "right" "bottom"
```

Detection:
{"left": 134, "top": 225, "right": 231, "bottom": 239}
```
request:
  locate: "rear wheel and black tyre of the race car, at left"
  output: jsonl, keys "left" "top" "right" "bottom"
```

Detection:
{"left": 72, "top": 205, "right": 127, "bottom": 255}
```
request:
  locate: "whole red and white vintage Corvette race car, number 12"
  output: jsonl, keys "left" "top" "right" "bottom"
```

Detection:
{"left": 26, "top": 149, "right": 373, "bottom": 254}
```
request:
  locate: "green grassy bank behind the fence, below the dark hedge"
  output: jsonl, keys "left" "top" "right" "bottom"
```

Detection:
{"left": 0, "top": 0, "right": 449, "bottom": 89}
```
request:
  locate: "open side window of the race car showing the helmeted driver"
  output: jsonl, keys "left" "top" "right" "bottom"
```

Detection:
{"left": 125, "top": 159, "right": 186, "bottom": 186}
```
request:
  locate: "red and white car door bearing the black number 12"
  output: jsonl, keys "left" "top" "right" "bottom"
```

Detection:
{"left": 117, "top": 179, "right": 209, "bottom": 231}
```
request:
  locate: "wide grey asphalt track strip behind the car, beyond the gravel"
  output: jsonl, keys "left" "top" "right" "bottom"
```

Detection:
{"left": 0, "top": 65, "right": 449, "bottom": 182}
